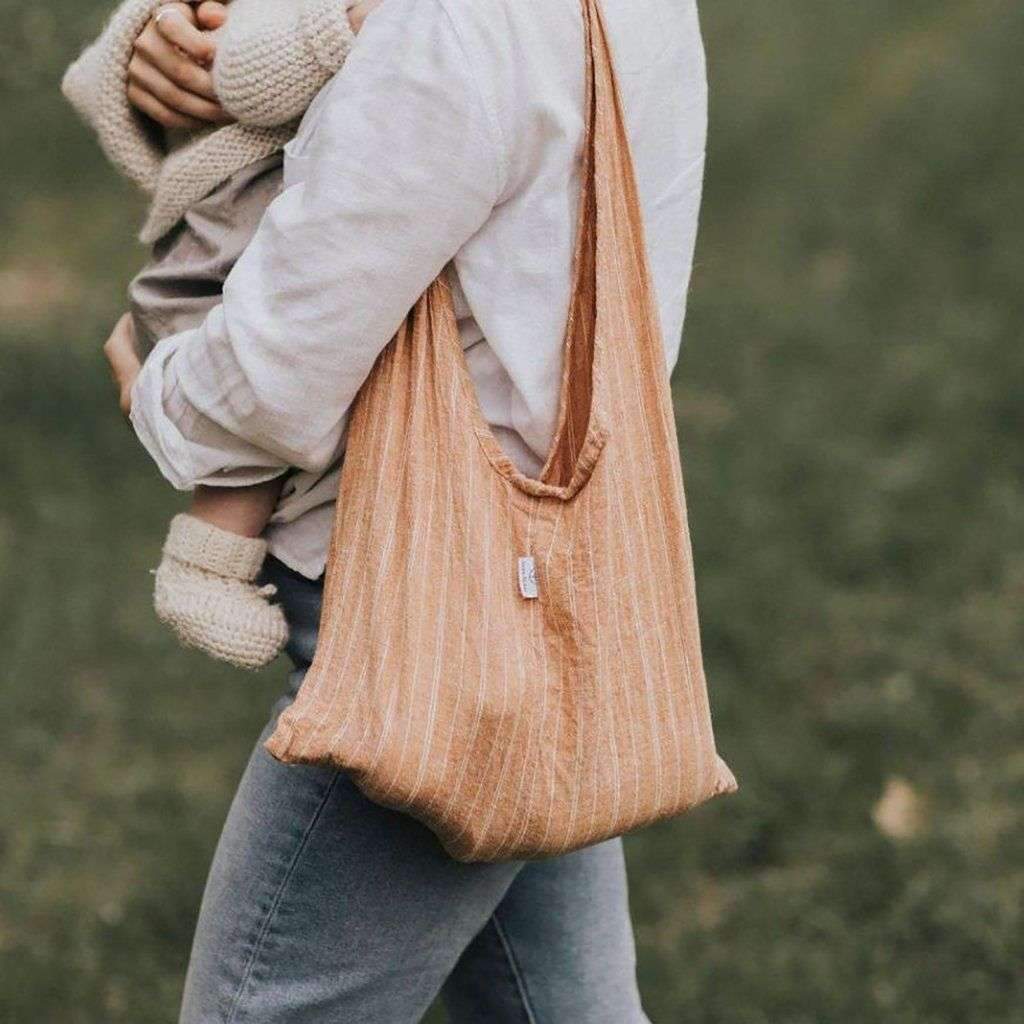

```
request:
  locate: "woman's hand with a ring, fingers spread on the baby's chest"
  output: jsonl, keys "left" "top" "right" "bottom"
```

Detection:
{"left": 128, "top": 0, "right": 231, "bottom": 129}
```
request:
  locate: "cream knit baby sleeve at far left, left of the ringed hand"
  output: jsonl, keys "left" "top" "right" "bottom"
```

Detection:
{"left": 60, "top": 0, "right": 165, "bottom": 191}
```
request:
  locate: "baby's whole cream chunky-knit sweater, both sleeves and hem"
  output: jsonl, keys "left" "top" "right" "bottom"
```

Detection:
{"left": 61, "top": 0, "right": 356, "bottom": 243}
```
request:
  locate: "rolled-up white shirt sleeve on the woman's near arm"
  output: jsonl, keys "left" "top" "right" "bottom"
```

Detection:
{"left": 131, "top": 0, "right": 505, "bottom": 489}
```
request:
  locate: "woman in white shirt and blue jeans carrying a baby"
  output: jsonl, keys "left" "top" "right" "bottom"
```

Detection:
{"left": 110, "top": 0, "right": 706, "bottom": 1024}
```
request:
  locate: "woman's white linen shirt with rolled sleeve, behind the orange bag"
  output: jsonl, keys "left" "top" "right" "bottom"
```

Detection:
{"left": 131, "top": 0, "right": 707, "bottom": 578}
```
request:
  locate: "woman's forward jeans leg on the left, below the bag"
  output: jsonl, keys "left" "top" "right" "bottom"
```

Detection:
{"left": 180, "top": 659, "right": 519, "bottom": 1024}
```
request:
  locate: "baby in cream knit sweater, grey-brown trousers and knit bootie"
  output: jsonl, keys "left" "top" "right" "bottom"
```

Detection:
{"left": 61, "top": 0, "right": 367, "bottom": 669}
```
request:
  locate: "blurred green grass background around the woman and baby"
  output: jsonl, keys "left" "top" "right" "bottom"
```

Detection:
{"left": 0, "top": 0, "right": 1024, "bottom": 1024}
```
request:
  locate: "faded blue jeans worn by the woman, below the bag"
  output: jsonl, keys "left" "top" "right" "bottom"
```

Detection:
{"left": 180, "top": 558, "right": 647, "bottom": 1024}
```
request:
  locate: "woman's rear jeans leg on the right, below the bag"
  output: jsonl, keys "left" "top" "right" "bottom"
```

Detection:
{"left": 443, "top": 839, "right": 647, "bottom": 1024}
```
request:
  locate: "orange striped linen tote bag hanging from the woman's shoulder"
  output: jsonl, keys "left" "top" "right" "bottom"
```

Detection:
{"left": 265, "top": 0, "right": 736, "bottom": 861}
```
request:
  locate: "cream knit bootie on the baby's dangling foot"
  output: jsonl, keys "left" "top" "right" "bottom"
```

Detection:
{"left": 154, "top": 512, "right": 288, "bottom": 669}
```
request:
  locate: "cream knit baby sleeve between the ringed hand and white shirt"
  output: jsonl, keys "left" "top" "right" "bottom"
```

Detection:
{"left": 213, "top": 0, "right": 356, "bottom": 127}
